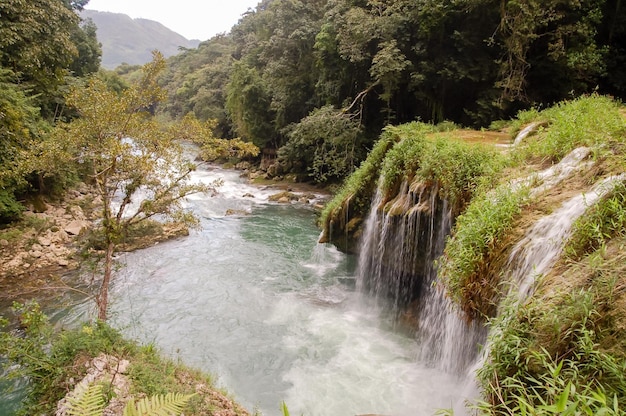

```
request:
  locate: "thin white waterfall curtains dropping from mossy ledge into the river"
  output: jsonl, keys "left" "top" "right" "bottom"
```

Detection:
{"left": 357, "top": 178, "right": 486, "bottom": 374}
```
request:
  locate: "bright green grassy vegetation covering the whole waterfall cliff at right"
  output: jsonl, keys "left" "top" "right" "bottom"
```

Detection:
{"left": 322, "top": 95, "right": 626, "bottom": 415}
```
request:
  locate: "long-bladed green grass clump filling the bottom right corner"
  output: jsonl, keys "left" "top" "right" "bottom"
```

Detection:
{"left": 477, "top": 272, "right": 626, "bottom": 416}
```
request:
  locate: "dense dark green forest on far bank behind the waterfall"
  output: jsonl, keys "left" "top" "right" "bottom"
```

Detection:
{"left": 164, "top": 0, "right": 626, "bottom": 182}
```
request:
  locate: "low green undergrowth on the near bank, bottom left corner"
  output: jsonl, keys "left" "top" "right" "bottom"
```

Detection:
{"left": 0, "top": 304, "right": 247, "bottom": 415}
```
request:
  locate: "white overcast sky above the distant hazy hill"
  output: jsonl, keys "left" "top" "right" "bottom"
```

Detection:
{"left": 85, "top": 0, "right": 259, "bottom": 40}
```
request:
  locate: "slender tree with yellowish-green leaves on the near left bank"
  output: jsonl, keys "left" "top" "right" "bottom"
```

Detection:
{"left": 45, "top": 53, "right": 209, "bottom": 320}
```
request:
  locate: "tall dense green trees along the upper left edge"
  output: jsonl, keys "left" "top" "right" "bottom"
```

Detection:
{"left": 0, "top": 0, "right": 101, "bottom": 224}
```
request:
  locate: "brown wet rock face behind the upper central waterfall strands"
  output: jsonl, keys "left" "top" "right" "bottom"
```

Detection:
{"left": 358, "top": 180, "right": 452, "bottom": 310}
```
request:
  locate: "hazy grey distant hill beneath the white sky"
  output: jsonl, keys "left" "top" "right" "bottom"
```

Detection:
{"left": 81, "top": 10, "right": 200, "bottom": 69}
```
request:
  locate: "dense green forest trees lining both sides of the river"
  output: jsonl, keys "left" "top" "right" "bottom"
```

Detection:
{"left": 0, "top": 0, "right": 626, "bottom": 224}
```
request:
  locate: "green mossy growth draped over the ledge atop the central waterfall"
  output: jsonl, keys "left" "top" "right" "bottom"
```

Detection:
{"left": 320, "top": 122, "right": 503, "bottom": 250}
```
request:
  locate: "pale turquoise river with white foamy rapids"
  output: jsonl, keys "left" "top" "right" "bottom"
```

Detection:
{"left": 2, "top": 161, "right": 465, "bottom": 416}
